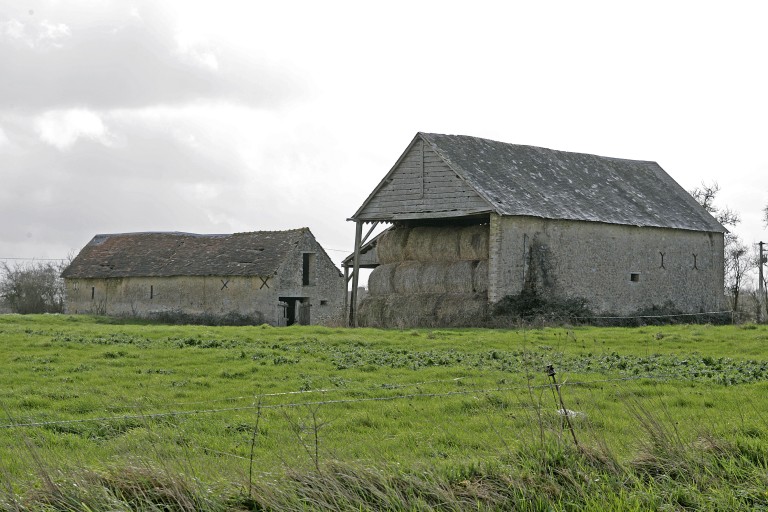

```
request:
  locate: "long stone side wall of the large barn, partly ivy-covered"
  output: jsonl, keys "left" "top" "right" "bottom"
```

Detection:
{"left": 489, "top": 215, "right": 724, "bottom": 314}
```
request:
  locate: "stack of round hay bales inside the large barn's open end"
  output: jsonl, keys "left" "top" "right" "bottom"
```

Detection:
{"left": 358, "top": 225, "right": 488, "bottom": 327}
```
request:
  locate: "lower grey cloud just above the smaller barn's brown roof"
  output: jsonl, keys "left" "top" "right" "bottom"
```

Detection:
{"left": 0, "top": 122, "right": 234, "bottom": 252}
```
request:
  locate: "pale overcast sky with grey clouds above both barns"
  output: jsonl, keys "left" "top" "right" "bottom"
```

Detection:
{"left": 0, "top": 0, "right": 768, "bottom": 276}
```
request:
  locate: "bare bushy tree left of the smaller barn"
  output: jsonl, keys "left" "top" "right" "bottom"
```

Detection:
{"left": 0, "top": 261, "right": 66, "bottom": 314}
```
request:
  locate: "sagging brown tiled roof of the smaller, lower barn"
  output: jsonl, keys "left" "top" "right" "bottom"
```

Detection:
{"left": 62, "top": 228, "right": 311, "bottom": 279}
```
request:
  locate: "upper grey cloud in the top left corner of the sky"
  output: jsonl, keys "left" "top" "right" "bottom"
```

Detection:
{"left": 0, "top": 3, "right": 303, "bottom": 110}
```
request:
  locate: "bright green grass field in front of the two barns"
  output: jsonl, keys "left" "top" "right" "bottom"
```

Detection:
{"left": 0, "top": 315, "right": 768, "bottom": 510}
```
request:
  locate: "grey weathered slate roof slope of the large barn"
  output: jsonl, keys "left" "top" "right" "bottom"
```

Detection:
{"left": 358, "top": 132, "right": 727, "bottom": 232}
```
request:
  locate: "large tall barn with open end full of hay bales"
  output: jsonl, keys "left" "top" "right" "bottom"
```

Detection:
{"left": 344, "top": 133, "right": 726, "bottom": 327}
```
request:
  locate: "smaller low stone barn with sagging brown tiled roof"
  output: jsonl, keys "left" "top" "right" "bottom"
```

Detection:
{"left": 62, "top": 228, "right": 345, "bottom": 325}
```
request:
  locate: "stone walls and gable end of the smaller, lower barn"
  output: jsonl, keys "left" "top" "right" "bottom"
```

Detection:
{"left": 65, "top": 234, "right": 345, "bottom": 325}
